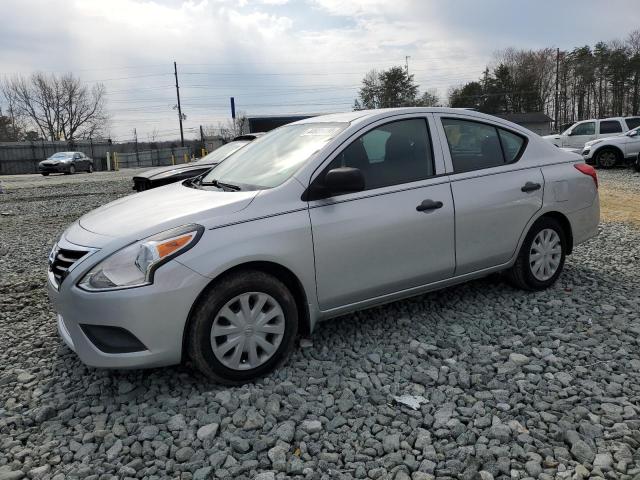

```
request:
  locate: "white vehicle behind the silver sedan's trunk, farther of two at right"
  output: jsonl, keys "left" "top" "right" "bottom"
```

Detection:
{"left": 542, "top": 117, "right": 640, "bottom": 153}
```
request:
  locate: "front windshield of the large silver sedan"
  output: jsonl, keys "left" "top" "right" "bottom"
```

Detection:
{"left": 202, "top": 122, "right": 347, "bottom": 190}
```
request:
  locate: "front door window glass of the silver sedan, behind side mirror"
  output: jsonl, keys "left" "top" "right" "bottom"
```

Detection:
{"left": 320, "top": 118, "right": 434, "bottom": 190}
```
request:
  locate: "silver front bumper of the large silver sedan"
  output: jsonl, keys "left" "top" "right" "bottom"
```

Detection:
{"left": 48, "top": 236, "right": 210, "bottom": 368}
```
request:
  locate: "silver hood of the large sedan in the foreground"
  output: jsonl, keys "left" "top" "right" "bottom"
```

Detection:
{"left": 79, "top": 183, "right": 257, "bottom": 239}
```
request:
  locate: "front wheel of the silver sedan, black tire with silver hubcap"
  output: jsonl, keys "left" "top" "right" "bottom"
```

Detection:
{"left": 186, "top": 270, "right": 298, "bottom": 384}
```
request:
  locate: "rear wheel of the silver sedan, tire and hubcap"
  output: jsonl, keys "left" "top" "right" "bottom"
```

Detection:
{"left": 507, "top": 217, "right": 567, "bottom": 291}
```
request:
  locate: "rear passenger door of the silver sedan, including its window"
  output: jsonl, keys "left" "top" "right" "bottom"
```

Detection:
{"left": 432, "top": 115, "right": 544, "bottom": 275}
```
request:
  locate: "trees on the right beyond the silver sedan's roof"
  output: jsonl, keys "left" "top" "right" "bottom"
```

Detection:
{"left": 354, "top": 30, "right": 640, "bottom": 126}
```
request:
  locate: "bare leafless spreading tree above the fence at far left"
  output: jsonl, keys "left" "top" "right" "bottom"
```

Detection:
{"left": 0, "top": 73, "right": 108, "bottom": 141}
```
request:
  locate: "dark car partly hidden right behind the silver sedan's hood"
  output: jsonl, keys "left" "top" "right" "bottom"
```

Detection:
{"left": 133, "top": 133, "right": 263, "bottom": 192}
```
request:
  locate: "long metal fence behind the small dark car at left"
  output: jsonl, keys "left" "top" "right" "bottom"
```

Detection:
{"left": 0, "top": 141, "right": 191, "bottom": 175}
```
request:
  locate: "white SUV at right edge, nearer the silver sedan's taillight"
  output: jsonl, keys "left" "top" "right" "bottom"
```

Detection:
{"left": 582, "top": 127, "right": 640, "bottom": 168}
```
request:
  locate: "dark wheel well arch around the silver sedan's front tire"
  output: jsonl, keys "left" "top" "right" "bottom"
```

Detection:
{"left": 182, "top": 262, "right": 311, "bottom": 360}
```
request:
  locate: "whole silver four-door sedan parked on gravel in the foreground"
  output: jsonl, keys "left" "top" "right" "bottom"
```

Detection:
{"left": 49, "top": 108, "right": 599, "bottom": 382}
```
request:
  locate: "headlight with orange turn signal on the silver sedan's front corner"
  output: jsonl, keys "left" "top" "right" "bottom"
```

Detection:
{"left": 78, "top": 224, "right": 204, "bottom": 291}
